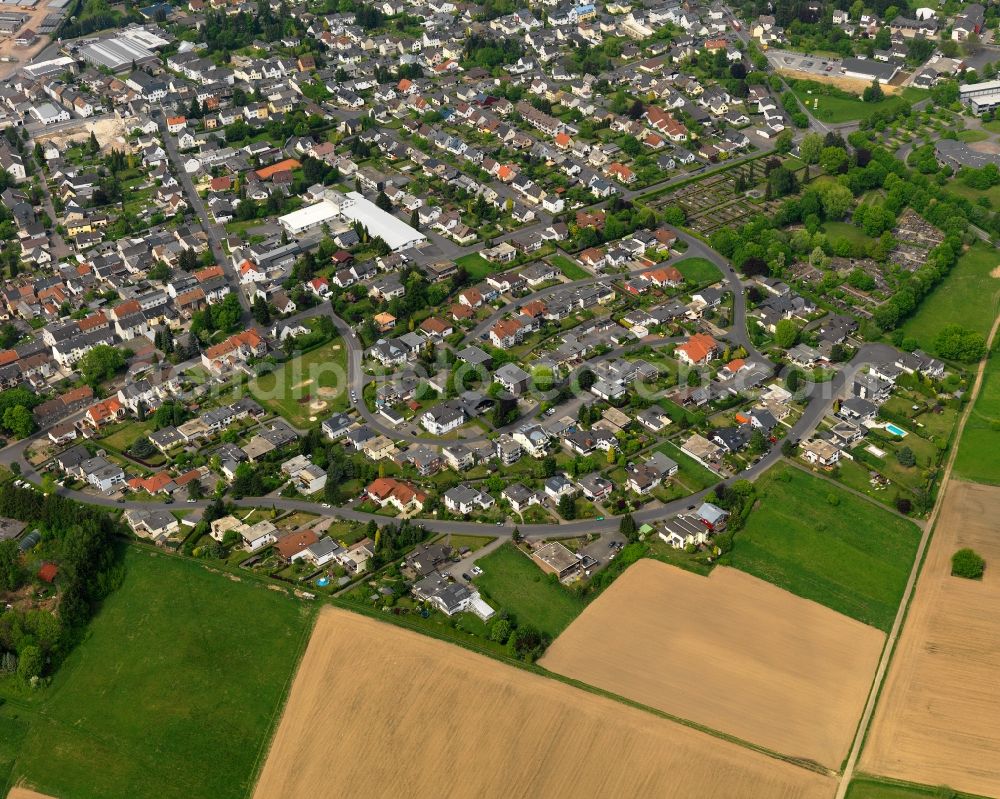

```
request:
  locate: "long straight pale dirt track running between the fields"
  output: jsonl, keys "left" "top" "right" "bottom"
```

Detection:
{"left": 836, "top": 316, "right": 1000, "bottom": 799}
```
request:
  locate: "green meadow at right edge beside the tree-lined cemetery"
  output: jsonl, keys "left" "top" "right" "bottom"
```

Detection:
{"left": 903, "top": 243, "right": 1000, "bottom": 352}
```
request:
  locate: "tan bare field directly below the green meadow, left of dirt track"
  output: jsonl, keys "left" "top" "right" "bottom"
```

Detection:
{"left": 539, "top": 560, "right": 884, "bottom": 768}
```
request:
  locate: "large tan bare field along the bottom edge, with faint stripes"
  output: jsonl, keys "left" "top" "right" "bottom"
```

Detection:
{"left": 254, "top": 608, "right": 834, "bottom": 799}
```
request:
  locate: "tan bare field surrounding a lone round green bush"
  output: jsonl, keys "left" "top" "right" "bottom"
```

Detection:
{"left": 861, "top": 479, "right": 1000, "bottom": 796}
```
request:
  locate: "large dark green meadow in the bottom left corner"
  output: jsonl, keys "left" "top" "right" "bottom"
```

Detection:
{"left": 0, "top": 547, "right": 313, "bottom": 799}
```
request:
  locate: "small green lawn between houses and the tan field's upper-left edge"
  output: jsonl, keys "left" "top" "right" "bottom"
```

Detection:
{"left": 475, "top": 543, "right": 585, "bottom": 638}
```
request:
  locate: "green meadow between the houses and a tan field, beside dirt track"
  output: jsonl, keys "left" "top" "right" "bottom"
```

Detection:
{"left": 720, "top": 467, "right": 920, "bottom": 630}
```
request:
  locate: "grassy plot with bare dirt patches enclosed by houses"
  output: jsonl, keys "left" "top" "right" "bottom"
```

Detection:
{"left": 250, "top": 338, "right": 349, "bottom": 428}
